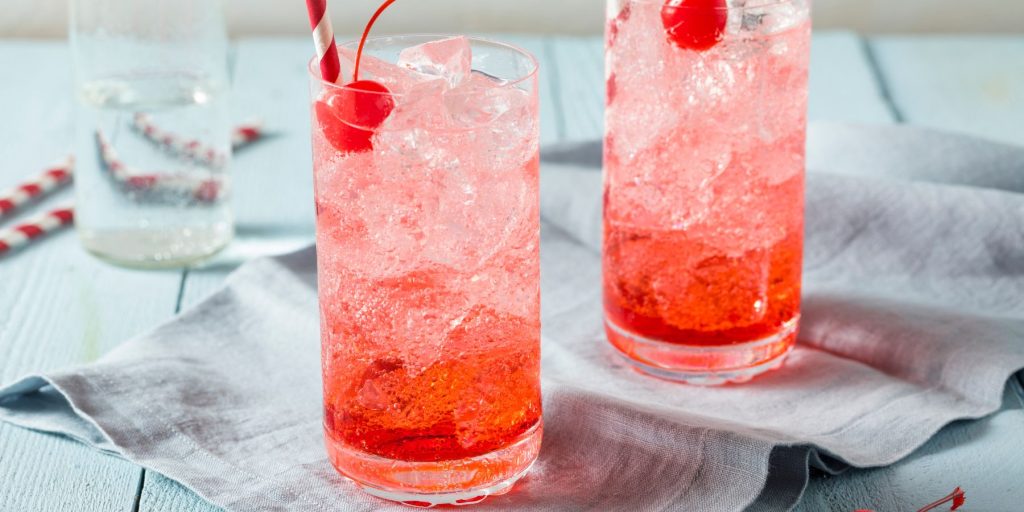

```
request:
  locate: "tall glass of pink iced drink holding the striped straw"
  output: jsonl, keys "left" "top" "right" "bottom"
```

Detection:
{"left": 310, "top": 36, "right": 542, "bottom": 505}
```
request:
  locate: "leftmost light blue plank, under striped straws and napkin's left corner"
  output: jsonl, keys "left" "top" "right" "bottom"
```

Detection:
{"left": 0, "top": 41, "right": 181, "bottom": 511}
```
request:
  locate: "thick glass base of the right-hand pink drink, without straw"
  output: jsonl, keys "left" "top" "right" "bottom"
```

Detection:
{"left": 604, "top": 315, "right": 800, "bottom": 386}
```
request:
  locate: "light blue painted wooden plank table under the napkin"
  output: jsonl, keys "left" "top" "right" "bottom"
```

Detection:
{"left": 0, "top": 33, "right": 1024, "bottom": 512}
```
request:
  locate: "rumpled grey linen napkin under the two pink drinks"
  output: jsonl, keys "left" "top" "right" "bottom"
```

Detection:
{"left": 0, "top": 121, "right": 1024, "bottom": 511}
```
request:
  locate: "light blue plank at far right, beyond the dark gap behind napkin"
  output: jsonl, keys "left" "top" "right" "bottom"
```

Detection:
{"left": 871, "top": 36, "right": 1024, "bottom": 144}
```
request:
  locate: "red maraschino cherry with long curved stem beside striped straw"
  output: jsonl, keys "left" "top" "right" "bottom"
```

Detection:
{"left": 315, "top": 0, "right": 396, "bottom": 153}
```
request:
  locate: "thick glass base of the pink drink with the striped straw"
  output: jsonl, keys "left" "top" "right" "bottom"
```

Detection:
{"left": 327, "top": 422, "right": 544, "bottom": 508}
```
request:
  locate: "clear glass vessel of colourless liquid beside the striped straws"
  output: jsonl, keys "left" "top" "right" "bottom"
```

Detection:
{"left": 70, "top": 0, "right": 233, "bottom": 267}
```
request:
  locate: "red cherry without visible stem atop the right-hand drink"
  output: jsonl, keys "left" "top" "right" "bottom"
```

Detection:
{"left": 662, "top": 0, "right": 728, "bottom": 51}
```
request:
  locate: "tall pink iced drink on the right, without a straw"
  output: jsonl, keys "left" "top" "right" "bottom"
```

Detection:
{"left": 603, "top": 0, "right": 811, "bottom": 384}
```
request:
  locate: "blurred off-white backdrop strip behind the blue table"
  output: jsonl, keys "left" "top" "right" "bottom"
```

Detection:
{"left": 0, "top": 0, "right": 1024, "bottom": 37}
